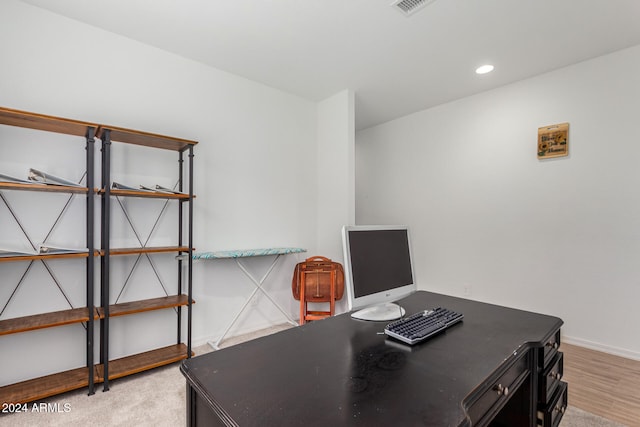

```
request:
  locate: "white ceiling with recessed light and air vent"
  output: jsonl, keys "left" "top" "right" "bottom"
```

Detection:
{"left": 22, "top": 0, "right": 640, "bottom": 129}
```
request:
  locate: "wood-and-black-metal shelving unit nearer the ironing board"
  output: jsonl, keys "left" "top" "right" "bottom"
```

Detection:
{"left": 97, "top": 126, "right": 197, "bottom": 390}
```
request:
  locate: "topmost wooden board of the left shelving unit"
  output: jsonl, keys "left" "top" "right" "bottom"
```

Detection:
{"left": 0, "top": 107, "right": 98, "bottom": 136}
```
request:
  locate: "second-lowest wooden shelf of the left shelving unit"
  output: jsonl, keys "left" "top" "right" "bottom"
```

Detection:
{"left": 0, "top": 307, "right": 99, "bottom": 335}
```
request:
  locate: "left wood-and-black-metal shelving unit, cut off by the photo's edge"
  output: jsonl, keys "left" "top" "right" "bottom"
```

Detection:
{"left": 0, "top": 107, "right": 99, "bottom": 403}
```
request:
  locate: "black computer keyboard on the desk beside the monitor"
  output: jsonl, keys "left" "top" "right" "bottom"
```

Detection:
{"left": 384, "top": 307, "right": 464, "bottom": 345}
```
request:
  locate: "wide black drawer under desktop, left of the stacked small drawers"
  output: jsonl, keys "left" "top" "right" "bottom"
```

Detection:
{"left": 468, "top": 352, "right": 531, "bottom": 425}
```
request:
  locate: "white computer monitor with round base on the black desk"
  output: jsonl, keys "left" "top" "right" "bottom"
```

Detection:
{"left": 342, "top": 225, "right": 417, "bottom": 321}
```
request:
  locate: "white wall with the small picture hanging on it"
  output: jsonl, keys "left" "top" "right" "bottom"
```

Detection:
{"left": 356, "top": 46, "right": 640, "bottom": 359}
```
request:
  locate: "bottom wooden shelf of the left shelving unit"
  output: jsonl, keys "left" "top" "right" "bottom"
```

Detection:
{"left": 0, "top": 368, "right": 98, "bottom": 403}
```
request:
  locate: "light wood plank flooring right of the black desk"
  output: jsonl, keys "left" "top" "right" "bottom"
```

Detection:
{"left": 560, "top": 343, "right": 640, "bottom": 426}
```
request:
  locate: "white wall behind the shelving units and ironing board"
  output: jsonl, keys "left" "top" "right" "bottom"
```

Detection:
{"left": 0, "top": 0, "right": 318, "bottom": 385}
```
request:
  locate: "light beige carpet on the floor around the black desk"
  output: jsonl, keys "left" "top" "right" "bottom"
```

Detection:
{"left": 0, "top": 325, "right": 621, "bottom": 427}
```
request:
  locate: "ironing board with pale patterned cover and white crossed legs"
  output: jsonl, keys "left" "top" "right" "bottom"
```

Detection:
{"left": 193, "top": 248, "right": 307, "bottom": 350}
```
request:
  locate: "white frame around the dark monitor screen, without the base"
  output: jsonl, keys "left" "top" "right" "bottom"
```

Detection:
{"left": 342, "top": 225, "right": 418, "bottom": 311}
